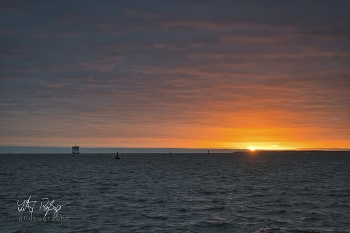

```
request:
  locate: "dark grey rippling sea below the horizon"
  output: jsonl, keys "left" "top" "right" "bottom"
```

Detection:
{"left": 0, "top": 151, "right": 350, "bottom": 233}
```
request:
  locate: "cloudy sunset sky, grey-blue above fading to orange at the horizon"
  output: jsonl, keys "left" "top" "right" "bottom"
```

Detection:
{"left": 0, "top": 0, "right": 350, "bottom": 149}
